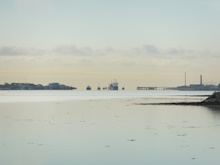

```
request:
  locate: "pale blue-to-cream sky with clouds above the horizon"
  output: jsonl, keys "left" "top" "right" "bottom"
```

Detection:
{"left": 0, "top": 0, "right": 220, "bottom": 90}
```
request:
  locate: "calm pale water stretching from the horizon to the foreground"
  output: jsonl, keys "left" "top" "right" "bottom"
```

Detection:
{"left": 0, "top": 91, "right": 220, "bottom": 165}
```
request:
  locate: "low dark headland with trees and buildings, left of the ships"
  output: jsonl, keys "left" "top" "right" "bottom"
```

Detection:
{"left": 0, "top": 83, "right": 77, "bottom": 90}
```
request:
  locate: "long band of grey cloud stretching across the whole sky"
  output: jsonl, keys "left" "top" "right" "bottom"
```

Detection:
{"left": 0, "top": 45, "right": 220, "bottom": 61}
